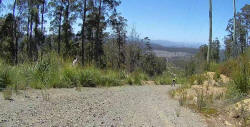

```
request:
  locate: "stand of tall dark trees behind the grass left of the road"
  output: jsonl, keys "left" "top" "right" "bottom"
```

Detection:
{"left": 0, "top": 0, "right": 172, "bottom": 88}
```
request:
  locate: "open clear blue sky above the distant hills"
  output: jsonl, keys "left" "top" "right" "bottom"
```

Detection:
{"left": 119, "top": 0, "right": 250, "bottom": 43}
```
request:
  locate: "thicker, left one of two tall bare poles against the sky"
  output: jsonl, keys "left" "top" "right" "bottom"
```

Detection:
{"left": 207, "top": 0, "right": 213, "bottom": 63}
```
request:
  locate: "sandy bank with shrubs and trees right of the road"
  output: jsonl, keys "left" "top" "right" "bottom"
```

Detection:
{"left": 170, "top": 5, "right": 250, "bottom": 127}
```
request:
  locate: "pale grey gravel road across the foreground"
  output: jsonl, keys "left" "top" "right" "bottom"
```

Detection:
{"left": 0, "top": 85, "right": 207, "bottom": 127}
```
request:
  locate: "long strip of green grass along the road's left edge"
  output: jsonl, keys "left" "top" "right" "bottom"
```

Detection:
{"left": 0, "top": 53, "right": 152, "bottom": 91}
